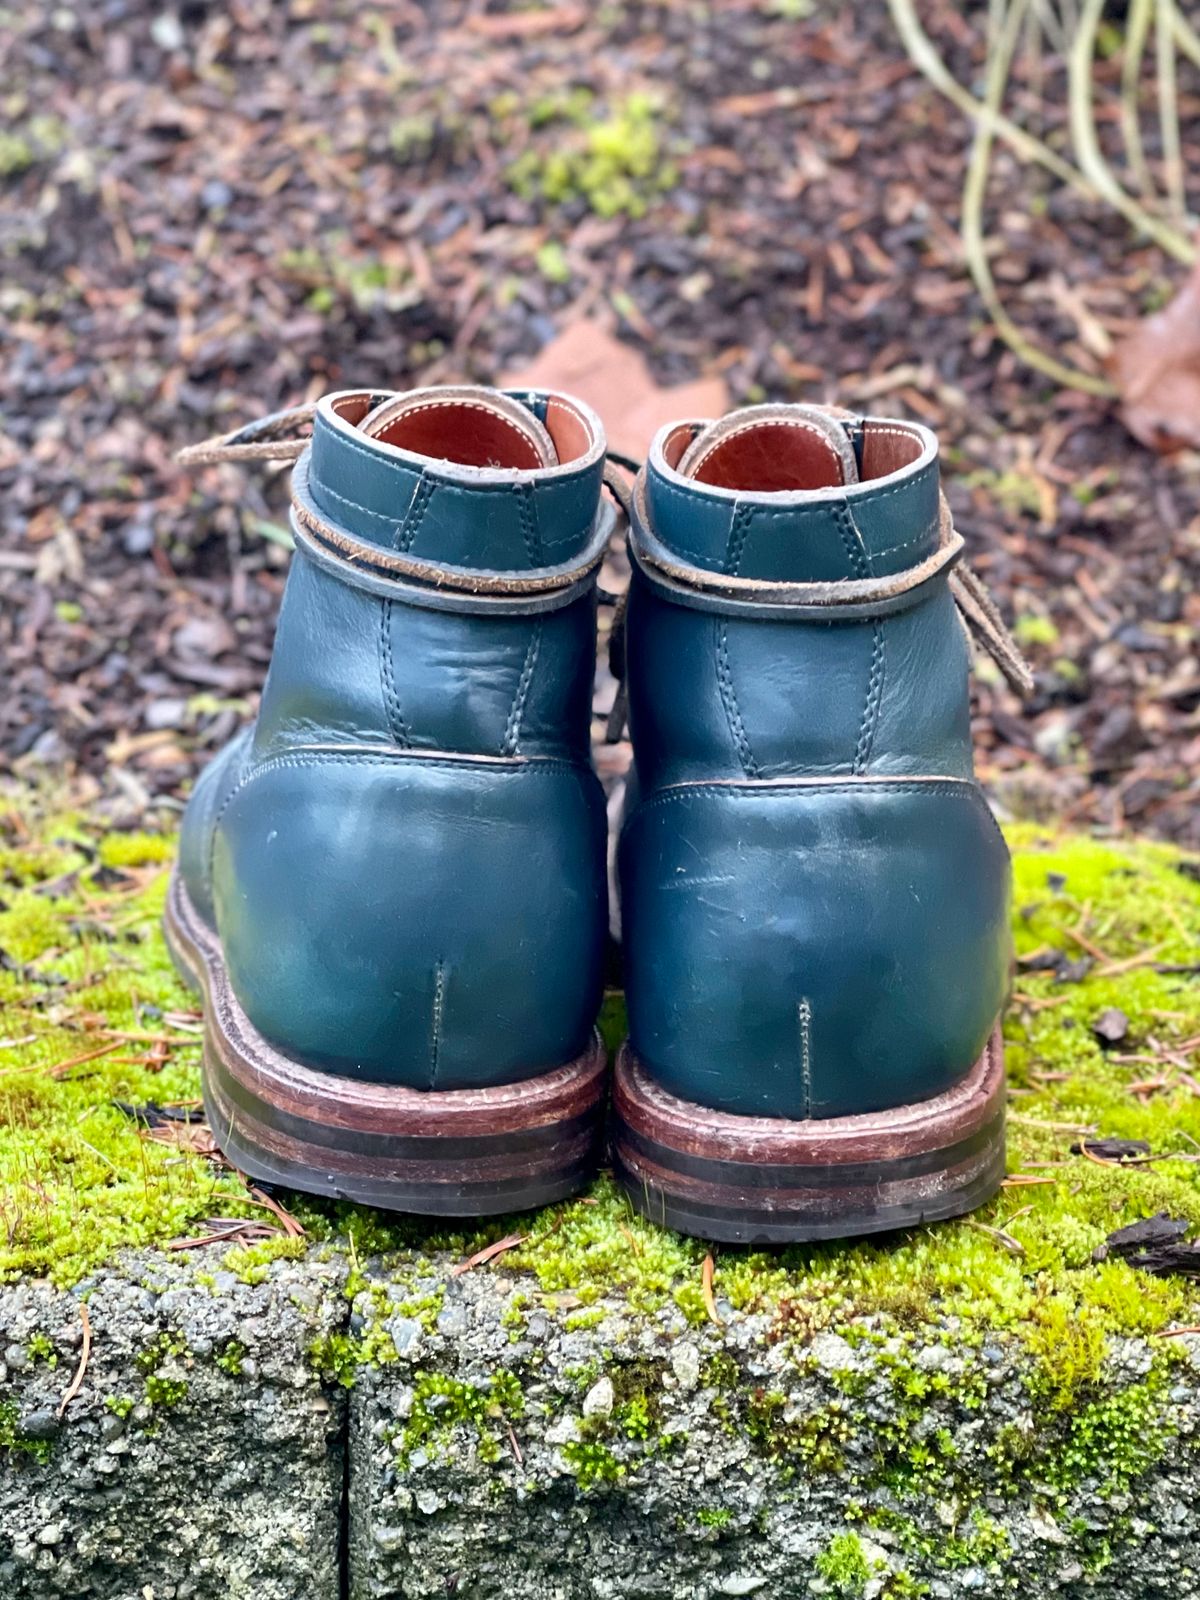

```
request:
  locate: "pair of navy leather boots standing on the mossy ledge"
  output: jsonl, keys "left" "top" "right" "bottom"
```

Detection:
{"left": 166, "top": 380, "right": 1021, "bottom": 1242}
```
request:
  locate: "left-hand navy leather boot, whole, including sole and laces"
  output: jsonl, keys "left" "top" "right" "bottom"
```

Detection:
{"left": 166, "top": 389, "right": 613, "bottom": 1214}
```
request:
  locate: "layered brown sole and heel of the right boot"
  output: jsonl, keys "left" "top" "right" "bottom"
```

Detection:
{"left": 613, "top": 1024, "right": 1005, "bottom": 1245}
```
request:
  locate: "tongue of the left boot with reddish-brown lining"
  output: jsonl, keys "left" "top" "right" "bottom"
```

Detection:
{"left": 360, "top": 384, "right": 558, "bottom": 472}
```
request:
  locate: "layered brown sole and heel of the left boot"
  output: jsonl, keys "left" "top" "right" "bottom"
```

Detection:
{"left": 163, "top": 875, "right": 606, "bottom": 1216}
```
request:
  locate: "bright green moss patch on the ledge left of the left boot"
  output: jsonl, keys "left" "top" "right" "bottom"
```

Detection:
{"left": 0, "top": 790, "right": 261, "bottom": 1285}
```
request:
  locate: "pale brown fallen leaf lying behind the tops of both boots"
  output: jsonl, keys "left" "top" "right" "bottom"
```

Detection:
{"left": 501, "top": 318, "right": 730, "bottom": 461}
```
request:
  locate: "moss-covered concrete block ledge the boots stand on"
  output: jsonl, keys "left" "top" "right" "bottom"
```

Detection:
{"left": 0, "top": 794, "right": 1200, "bottom": 1600}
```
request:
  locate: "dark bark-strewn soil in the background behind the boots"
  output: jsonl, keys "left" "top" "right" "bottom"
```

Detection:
{"left": 0, "top": 0, "right": 1200, "bottom": 843}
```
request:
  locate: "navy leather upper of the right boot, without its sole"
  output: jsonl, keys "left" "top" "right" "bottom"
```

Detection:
{"left": 619, "top": 408, "right": 1010, "bottom": 1117}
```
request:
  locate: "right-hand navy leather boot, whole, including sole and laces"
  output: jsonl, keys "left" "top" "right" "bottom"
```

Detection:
{"left": 614, "top": 406, "right": 1027, "bottom": 1242}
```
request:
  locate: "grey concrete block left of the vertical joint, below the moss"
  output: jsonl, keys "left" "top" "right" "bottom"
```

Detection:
{"left": 0, "top": 1251, "right": 346, "bottom": 1600}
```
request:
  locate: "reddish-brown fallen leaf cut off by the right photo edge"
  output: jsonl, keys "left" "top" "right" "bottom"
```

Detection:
{"left": 1109, "top": 262, "right": 1200, "bottom": 454}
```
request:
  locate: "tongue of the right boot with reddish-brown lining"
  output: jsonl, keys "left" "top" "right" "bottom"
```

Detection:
{"left": 675, "top": 405, "right": 858, "bottom": 494}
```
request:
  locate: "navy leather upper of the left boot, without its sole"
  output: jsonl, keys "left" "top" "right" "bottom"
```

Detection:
{"left": 181, "top": 390, "right": 611, "bottom": 1088}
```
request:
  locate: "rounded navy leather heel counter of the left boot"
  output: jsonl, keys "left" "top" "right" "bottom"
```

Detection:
{"left": 213, "top": 752, "right": 606, "bottom": 1090}
